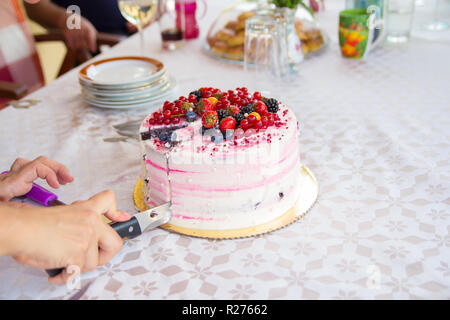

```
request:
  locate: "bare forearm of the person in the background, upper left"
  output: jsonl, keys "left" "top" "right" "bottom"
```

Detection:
{"left": 24, "top": 0, "right": 68, "bottom": 29}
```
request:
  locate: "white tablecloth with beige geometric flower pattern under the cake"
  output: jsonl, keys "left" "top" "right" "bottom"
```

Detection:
{"left": 0, "top": 1, "right": 450, "bottom": 299}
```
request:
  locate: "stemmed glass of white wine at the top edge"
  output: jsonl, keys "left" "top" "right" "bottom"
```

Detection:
{"left": 117, "top": 0, "right": 158, "bottom": 54}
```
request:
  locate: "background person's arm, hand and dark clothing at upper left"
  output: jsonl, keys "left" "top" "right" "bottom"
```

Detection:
{"left": 24, "top": 0, "right": 137, "bottom": 53}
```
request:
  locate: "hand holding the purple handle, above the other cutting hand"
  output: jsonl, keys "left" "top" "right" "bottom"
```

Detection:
{"left": 0, "top": 156, "right": 73, "bottom": 201}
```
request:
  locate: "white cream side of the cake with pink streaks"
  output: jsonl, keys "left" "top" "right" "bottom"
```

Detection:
{"left": 140, "top": 104, "right": 301, "bottom": 230}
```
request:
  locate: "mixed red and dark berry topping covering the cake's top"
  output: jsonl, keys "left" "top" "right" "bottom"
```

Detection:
{"left": 141, "top": 87, "right": 288, "bottom": 146}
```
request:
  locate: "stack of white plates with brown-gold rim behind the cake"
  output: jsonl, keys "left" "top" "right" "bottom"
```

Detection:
{"left": 78, "top": 57, "right": 178, "bottom": 109}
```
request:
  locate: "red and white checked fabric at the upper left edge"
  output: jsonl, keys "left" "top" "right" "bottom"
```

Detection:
{"left": 0, "top": 0, "right": 44, "bottom": 109}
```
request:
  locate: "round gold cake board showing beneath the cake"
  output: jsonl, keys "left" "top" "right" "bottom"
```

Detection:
{"left": 133, "top": 166, "right": 319, "bottom": 239}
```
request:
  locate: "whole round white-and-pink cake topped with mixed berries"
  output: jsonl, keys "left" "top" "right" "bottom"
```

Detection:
{"left": 140, "top": 88, "right": 301, "bottom": 230}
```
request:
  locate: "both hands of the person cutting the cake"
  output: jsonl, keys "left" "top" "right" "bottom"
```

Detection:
{"left": 0, "top": 157, "right": 131, "bottom": 284}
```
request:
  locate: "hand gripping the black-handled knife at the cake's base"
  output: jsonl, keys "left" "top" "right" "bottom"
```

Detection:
{"left": 2, "top": 191, "right": 131, "bottom": 284}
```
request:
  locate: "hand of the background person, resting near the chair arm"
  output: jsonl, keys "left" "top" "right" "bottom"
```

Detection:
{"left": 63, "top": 17, "right": 97, "bottom": 52}
